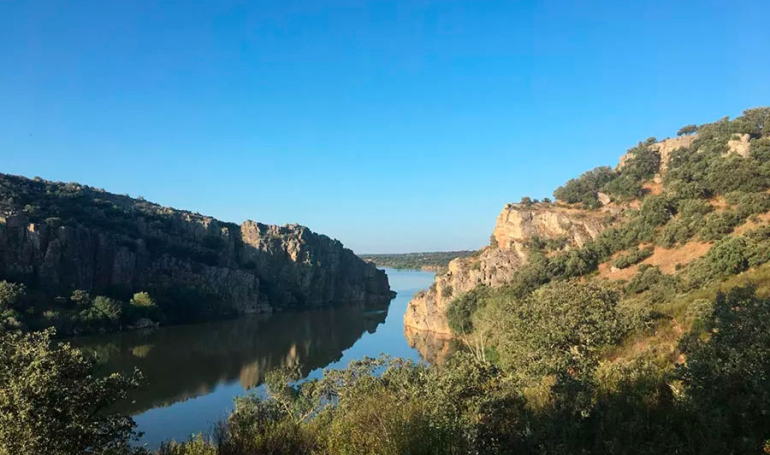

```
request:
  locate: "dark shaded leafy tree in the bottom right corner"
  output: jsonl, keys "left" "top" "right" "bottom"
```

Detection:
{"left": 678, "top": 287, "right": 770, "bottom": 454}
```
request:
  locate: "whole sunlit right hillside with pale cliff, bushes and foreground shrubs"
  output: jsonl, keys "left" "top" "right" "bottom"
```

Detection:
{"left": 142, "top": 108, "right": 770, "bottom": 455}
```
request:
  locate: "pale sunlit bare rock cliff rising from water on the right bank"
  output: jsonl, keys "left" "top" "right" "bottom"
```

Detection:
{"left": 404, "top": 204, "right": 608, "bottom": 338}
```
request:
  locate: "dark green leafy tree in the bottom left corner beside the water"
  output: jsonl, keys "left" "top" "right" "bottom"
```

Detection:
{"left": 0, "top": 329, "right": 141, "bottom": 455}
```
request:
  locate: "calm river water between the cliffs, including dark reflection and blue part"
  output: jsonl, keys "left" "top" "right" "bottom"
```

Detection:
{"left": 72, "top": 269, "right": 433, "bottom": 448}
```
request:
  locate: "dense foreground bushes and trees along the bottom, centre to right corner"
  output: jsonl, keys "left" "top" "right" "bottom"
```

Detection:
{"left": 152, "top": 282, "right": 770, "bottom": 455}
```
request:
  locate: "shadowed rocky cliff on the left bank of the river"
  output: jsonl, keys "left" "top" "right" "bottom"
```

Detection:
{"left": 0, "top": 174, "right": 390, "bottom": 313}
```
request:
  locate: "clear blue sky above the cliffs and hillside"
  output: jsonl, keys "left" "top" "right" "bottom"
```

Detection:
{"left": 0, "top": 0, "right": 770, "bottom": 253}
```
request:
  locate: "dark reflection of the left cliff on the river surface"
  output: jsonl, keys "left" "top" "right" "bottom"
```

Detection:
{"left": 72, "top": 304, "right": 388, "bottom": 414}
